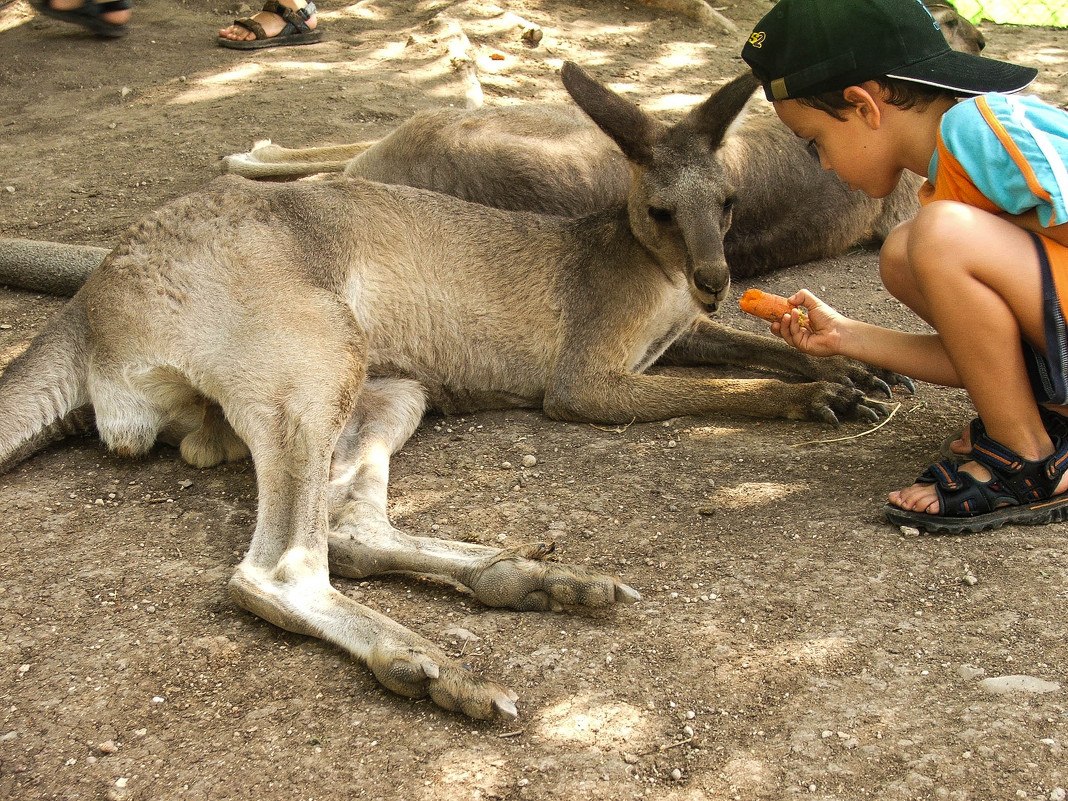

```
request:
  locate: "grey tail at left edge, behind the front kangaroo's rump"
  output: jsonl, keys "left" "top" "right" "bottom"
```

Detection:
{"left": 0, "top": 239, "right": 108, "bottom": 297}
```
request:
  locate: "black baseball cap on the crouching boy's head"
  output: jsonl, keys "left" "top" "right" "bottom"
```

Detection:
{"left": 741, "top": 0, "right": 1038, "bottom": 100}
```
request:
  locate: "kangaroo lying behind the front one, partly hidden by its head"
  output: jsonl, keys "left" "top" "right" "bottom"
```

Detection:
{"left": 222, "top": 2, "right": 986, "bottom": 280}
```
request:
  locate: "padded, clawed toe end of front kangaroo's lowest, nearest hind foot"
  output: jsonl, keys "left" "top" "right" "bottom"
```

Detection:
{"left": 367, "top": 642, "right": 518, "bottom": 720}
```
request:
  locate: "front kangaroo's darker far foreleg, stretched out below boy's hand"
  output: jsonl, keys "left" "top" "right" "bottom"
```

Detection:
{"left": 660, "top": 317, "right": 915, "bottom": 396}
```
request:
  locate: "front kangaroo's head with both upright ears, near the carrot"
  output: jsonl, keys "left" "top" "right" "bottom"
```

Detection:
{"left": 561, "top": 62, "right": 758, "bottom": 311}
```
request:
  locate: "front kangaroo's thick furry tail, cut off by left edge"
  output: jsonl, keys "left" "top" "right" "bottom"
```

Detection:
{"left": 0, "top": 298, "right": 93, "bottom": 473}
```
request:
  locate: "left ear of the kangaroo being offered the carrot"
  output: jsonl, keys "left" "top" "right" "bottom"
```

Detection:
{"left": 560, "top": 61, "right": 666, "bottom": 164}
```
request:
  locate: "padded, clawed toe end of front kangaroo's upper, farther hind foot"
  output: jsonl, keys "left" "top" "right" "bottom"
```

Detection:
{"left": 464, "top": 544, "right": 642, "bottom": 612}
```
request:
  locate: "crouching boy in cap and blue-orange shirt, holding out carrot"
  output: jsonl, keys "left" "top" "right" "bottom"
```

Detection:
{"left": 742, "top": 0, "right": 1068, "bottom": 540}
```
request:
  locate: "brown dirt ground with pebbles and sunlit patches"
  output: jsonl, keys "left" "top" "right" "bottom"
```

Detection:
{"left": 0, "top": 0, "right": 1068, "bottom": 801}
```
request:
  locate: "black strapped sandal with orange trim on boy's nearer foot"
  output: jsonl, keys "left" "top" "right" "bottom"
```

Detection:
{"left": 883, "top": 429, "right": 1068, "bottom": 534}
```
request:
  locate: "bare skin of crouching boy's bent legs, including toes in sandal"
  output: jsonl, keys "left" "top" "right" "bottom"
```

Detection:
{"left": 882, "top": 202, "right": 1068, "bottom": 514}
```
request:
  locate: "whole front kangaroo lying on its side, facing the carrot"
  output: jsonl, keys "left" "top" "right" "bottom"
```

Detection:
{"left": 0, "top": 63, "right": 909, "bottom": 718}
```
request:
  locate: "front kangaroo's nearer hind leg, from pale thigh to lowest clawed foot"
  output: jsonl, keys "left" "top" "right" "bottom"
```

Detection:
{"left": 212, "top": 294, "right": 515, "bottom": 718}
